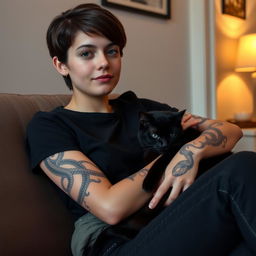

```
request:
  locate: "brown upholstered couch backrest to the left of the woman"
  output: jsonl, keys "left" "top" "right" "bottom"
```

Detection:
{"left": 0, "top": 94, "right": 73, "bottom": 256}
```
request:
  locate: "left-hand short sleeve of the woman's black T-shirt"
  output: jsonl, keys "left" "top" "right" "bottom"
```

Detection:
{"left": 26, "top": 112, "right": 79, "bottom": 169}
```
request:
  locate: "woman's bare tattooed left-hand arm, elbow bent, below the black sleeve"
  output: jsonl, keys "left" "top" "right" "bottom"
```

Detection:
{"left": 40, "top": 151, "right": 156, "bottom": 224}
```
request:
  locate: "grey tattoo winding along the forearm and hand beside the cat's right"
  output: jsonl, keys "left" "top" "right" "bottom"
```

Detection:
{"left": 172, "top": 120, "right": 227, "bottom": 177}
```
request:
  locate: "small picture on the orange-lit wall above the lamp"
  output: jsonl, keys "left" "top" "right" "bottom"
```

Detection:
{"left": 222, "top": 0, "right": 246, "bottom": 19}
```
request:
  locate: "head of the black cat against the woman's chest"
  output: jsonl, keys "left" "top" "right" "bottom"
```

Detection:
{"left": 138, "top": 110, "right": 185, "bottom": 153}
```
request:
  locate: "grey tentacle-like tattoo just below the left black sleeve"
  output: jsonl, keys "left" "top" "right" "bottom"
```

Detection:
{"left": 44, "top": 152, "right": 105, "bottom": 208}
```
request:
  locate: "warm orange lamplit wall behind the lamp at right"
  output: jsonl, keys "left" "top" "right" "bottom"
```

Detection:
{"left": 215, "top": 0, "right": 256, "bottom": 120}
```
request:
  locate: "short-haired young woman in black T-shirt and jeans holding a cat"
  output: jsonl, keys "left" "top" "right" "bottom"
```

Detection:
{"left": 28, "top": 4, "right": 256, "bottom": 256}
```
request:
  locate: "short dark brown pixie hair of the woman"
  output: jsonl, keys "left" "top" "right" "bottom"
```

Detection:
{"left": 46, "top": 4, "right": 126, "bottom": 90}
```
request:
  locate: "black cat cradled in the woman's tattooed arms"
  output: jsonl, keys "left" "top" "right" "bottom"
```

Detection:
{"left": 138, "top": 110, "right": 196, "bottom": 192}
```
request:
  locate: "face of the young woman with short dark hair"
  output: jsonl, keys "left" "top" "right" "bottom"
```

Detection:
{"left": 60, "top": 32, "right": 121, "bottom": 96}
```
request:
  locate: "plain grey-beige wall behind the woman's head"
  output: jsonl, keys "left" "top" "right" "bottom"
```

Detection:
{"left": 0, "top": 0, "right": 190, "bottom": 110}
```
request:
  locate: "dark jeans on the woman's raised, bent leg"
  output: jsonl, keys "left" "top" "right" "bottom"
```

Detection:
{"left": 100, "top": 152, "right": 256, "bottom": 256}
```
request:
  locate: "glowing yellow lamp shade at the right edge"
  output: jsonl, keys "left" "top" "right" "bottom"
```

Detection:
{"left": 235, "top": 33, "right": 256, "bottom": 72}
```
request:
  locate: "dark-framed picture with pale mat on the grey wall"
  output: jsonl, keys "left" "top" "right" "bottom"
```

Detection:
{"left": 101, "top": 0, "right": 171, "bottom": 19}
